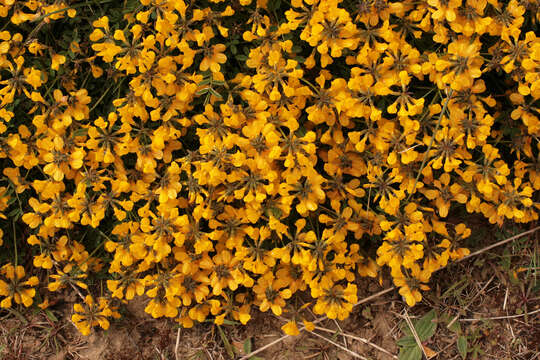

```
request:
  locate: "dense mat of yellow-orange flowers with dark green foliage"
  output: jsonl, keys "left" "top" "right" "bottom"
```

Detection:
{"left": 0, "top": 0, "right": 540, "bottom": 334}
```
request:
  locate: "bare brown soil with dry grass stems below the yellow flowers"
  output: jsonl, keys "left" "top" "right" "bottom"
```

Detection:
{"left": 0, "top": 228, "right": 540, "bottom": 360}
